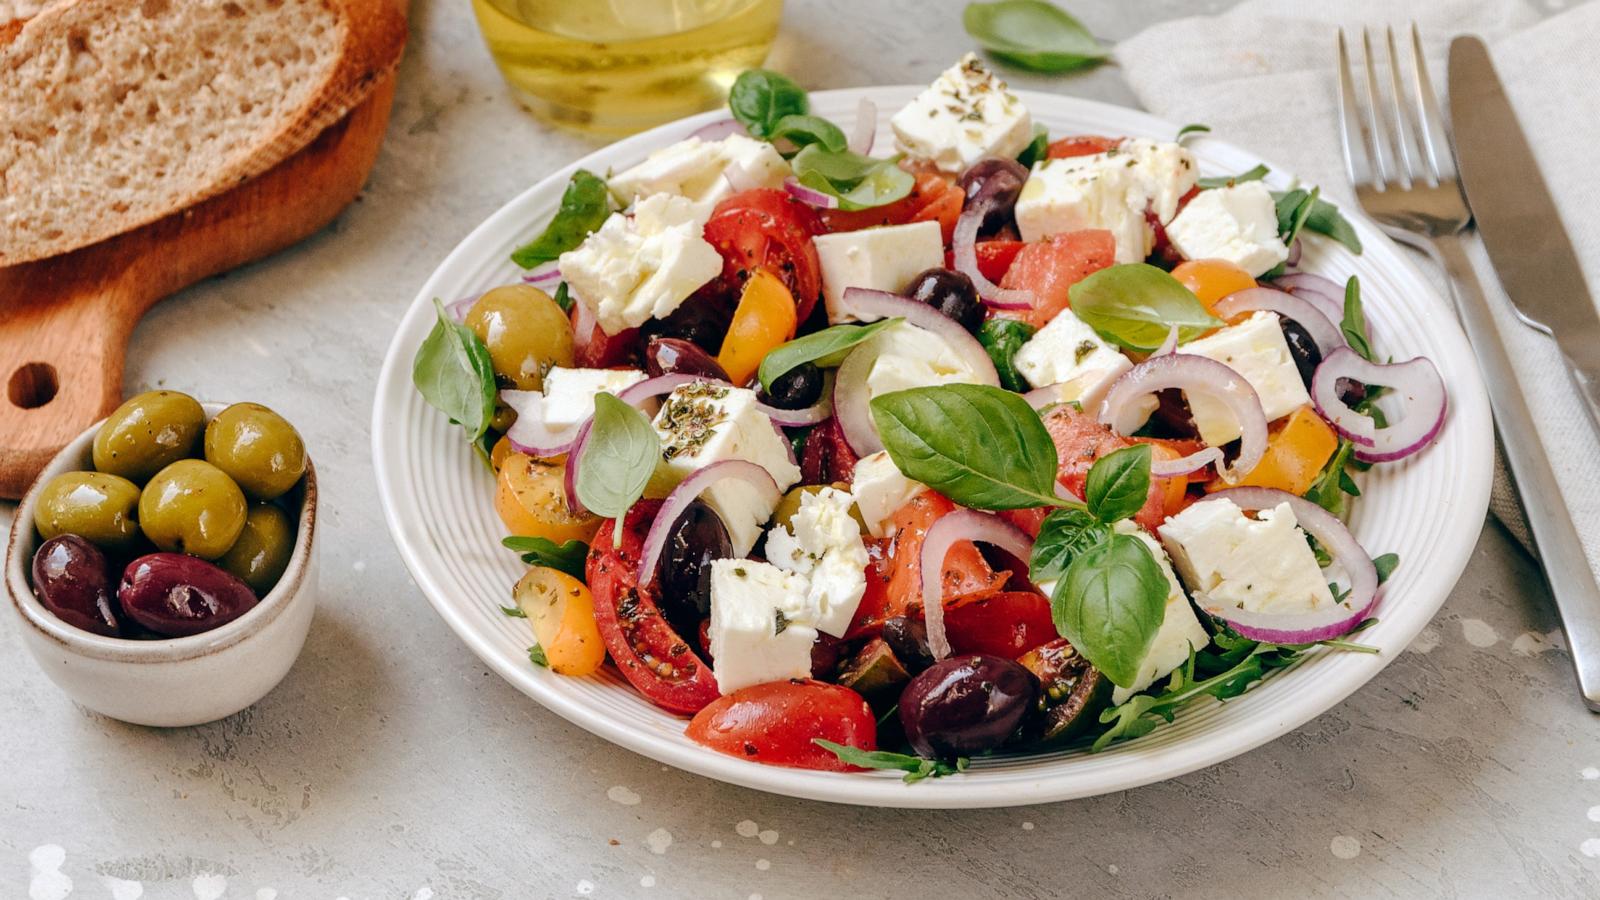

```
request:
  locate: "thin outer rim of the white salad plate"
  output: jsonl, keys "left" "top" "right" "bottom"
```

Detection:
{"left": 371, "top": 85, "right": 1493, "bottom": 809}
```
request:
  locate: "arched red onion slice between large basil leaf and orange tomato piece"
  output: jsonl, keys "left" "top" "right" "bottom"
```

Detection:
{"left": 1099, "top": 354, "right": 1267, "bottom": 484}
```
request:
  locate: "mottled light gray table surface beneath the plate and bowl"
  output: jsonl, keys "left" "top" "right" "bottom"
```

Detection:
{"left": 0, "top": 0, "right": 1600, "bottom": 900}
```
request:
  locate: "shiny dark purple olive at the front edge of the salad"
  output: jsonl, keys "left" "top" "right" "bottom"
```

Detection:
{"left": 899, "top": 653, "right": 1038, "bottom": 759}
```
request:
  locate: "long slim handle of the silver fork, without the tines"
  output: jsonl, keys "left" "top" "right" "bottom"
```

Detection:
{"left": 1432, "top": 234, "right": 1600, "bottom": 713}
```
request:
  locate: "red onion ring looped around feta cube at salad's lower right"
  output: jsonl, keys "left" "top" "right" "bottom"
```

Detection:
{"left": 1196, "top": 487, "right": 1378, "bottom": 644}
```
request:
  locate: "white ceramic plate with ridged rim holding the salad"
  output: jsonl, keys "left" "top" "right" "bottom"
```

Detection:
{"left": 373, "top": 86, "right": 1493, "bottom": 807}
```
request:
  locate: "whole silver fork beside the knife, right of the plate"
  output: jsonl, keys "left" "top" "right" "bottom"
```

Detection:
{"left": 1339, "top": 22, "right": 1600, "bottom": 713}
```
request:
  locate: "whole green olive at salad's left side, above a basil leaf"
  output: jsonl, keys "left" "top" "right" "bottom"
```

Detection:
{"left": 466, "top": 285, "right": 573, "bottom": 391}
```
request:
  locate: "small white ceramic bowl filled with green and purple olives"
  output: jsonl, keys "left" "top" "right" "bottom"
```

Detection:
{"left": 5, "top": 391, "right": 317, "bottom": 727}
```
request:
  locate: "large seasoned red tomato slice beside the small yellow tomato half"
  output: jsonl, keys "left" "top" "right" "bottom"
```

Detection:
{"left": 586, "top": 500, "right": 720, "bottom": 716}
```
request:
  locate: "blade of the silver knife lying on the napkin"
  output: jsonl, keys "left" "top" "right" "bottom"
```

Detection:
{"left": 1450, "top": 35, "right": 1600, "bottom": 426}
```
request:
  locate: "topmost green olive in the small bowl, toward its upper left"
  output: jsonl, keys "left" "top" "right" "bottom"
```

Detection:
{"left": 94, "top": 391, "right": 205, "bottom": 484}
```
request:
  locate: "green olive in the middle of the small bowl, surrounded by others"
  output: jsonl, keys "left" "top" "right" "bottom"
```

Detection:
{"left": 139, "top": 460, "right": 246, "bottom": 559}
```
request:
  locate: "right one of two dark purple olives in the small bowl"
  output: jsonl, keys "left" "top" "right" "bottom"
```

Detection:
{"left": 117, "top": 552, "right": 256, "bottom": 637}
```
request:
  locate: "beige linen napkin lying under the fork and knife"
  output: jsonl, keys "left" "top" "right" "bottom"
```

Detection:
{"left": 1117, "top": 0, "right": 1600, "bottom": 570}
